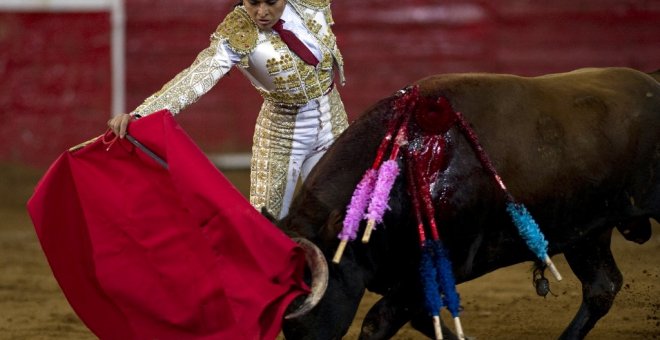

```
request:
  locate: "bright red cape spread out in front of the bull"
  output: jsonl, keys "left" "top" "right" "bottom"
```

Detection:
{"left": 28, "top": 111, "right": 307, "bottom": 339}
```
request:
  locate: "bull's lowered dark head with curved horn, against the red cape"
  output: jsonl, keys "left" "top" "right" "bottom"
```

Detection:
{"left": 262, "top": 198, "right": 364, "bottom": 339}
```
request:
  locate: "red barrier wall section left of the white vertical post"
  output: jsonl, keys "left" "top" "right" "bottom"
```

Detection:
{"left": 0, "top": 13, "right": 111, "bottom": 166}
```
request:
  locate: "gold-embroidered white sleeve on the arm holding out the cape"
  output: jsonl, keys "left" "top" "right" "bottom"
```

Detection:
{"left": 131, "top": 14, "right": 244, "bottom": 116}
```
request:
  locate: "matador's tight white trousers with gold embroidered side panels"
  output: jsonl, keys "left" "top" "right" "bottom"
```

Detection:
{"left": 250, "top": 89, "right": 348, "bottom": 218}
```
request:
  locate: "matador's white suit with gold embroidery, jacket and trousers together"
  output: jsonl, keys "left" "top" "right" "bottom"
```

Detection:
{"left": 131, "top": 0, "right": 348, "bottom": 218}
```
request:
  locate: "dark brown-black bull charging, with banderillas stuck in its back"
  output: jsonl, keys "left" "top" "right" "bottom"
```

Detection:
{"left": 279, "top": 68, "right": 660, "bottom": 339}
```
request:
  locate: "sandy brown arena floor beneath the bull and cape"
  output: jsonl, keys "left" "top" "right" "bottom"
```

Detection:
{"left": 0, "top": 165, "right": 660, "bottom": 340}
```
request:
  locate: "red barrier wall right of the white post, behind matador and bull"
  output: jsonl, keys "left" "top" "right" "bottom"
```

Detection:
{"left": 127, "top": 0, "right": 660, "bottom": 152}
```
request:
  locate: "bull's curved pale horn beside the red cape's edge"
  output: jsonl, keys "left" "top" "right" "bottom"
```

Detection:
{"left": 284, "top": 238, "right": 328, "bottom": 320}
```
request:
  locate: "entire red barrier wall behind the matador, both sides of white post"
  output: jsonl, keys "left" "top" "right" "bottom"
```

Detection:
{"left": 0, "top": 0, "right": 660, "bottom": 165}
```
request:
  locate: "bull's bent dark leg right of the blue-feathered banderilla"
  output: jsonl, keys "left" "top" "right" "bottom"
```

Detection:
{"left": 561, "top": 229, "right": 623, "bottom": 339}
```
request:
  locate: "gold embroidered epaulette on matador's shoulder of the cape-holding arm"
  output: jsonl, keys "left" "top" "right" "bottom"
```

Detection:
{"left": 212, "top": 6, "right": 259, "bottom": 55}
